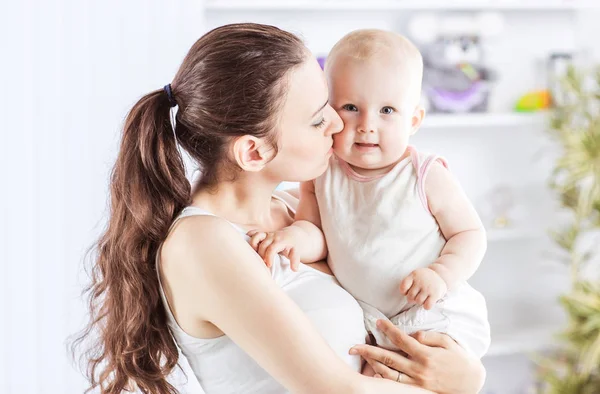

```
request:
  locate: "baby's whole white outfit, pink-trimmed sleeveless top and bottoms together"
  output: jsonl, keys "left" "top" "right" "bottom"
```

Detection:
{"left": 315, "top": 147, "right": 490, "bottom": 357}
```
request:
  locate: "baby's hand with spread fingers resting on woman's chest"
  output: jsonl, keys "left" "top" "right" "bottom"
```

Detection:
{"left": 248, "top": 226, "right": 302, "bottom": 271}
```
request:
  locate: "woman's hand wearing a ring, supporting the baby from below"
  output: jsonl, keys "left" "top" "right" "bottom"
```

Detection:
{"left": 350, "top": 320, "right": 485, "bottom": 394}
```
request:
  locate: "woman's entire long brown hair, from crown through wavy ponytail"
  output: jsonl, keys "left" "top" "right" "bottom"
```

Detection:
{"left": 73, "top": 24, "right": 306, "bottom": 394}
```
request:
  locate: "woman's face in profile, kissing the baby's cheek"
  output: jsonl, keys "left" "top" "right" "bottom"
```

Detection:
{"left": 268, "top": 56, "right": 343, "bottom": 182}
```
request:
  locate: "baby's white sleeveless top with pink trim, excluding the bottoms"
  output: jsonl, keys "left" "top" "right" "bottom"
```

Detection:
{"left": 315, "top": 147, "right": 446, "bottom": 318}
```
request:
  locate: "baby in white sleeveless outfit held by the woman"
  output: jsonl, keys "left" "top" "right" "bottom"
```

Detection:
{"left": 250, "top": 30, "right": 490, "bottom": 366}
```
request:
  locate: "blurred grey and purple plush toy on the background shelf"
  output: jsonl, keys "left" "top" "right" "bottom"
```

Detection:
{"left": 409, "top": 12, "right": 504, "bottom": 113}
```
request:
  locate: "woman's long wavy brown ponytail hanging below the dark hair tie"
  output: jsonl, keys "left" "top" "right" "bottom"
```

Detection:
{"left": 74, "top": 86, "right": 191, "bottom": 394}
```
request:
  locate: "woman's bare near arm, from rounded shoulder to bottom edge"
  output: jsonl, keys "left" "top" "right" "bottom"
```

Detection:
{"left": 162, "top": 216, "right": 432, "bottom": 394}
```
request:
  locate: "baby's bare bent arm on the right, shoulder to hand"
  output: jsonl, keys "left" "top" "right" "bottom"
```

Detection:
{"left": 400, "top": 162, "right": 487, "bottom": 309}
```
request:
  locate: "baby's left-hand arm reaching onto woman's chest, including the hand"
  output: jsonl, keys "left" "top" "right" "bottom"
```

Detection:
{"left": 248, "top": 181, "right": 327, "bottom": 271}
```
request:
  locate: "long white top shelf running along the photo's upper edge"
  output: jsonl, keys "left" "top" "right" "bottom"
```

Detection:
{"left": 206, "top": 0, "right": 598, "bottom": 11}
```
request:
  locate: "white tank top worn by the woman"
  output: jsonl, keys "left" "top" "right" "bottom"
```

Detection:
{"left": 157, "top": 192, "right": 366, "bottom": 394}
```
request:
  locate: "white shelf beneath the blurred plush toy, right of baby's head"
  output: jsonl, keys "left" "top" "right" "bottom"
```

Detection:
{"left": 422, "top": 113, "right": 548, "bottom": 129}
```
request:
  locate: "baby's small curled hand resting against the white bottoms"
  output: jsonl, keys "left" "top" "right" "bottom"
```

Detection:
{"left": 400, "top": 268, "right": 448, "bottom": 310}
